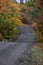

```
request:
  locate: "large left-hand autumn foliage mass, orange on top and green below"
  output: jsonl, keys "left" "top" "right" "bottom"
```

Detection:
{"left": 0, "top": 0, "right": 21, "bottom": 40}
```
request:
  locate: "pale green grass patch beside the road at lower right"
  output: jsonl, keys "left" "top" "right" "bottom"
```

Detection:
{"left": 31, "top": 43, "right": 43, "bottom": 65}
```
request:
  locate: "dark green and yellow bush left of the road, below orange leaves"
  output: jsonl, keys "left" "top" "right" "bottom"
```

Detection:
{"left": 0, "top": 14, "right": 18, "bottom": 41}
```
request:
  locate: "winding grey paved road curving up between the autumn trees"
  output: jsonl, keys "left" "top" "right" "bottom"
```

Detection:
{"left": 0, "top": 26, "right": 36, "bottom": 65}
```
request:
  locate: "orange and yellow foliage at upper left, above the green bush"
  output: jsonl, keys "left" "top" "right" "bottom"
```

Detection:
{"left": 0, "top": 0, "right": 22, "bottom": 24}
